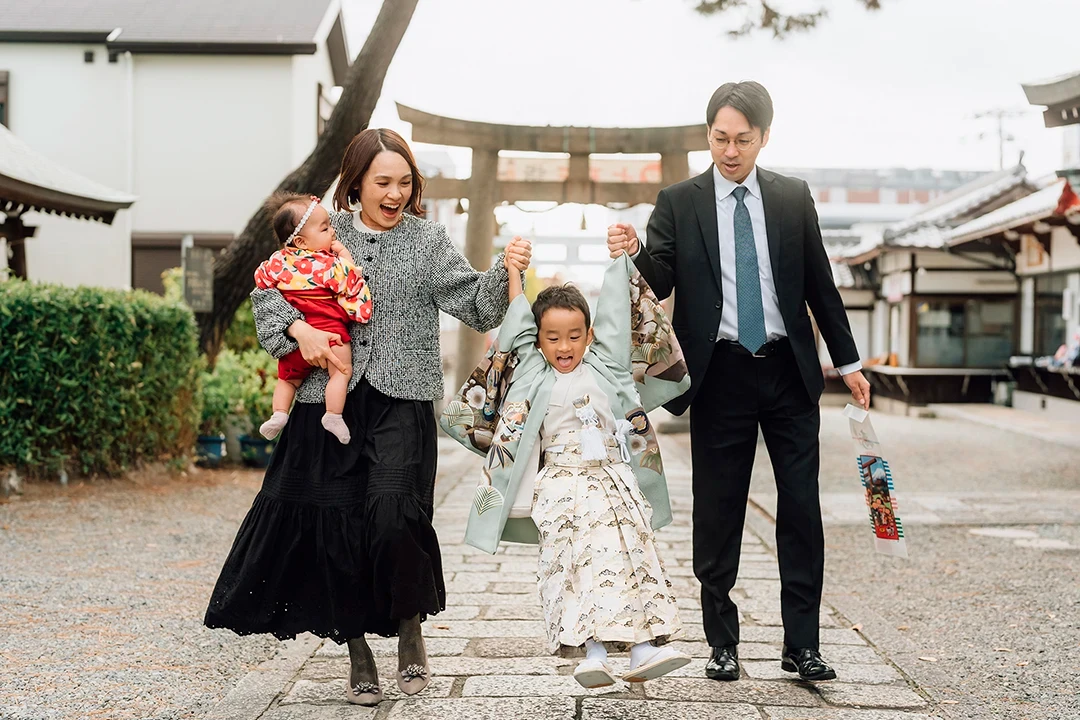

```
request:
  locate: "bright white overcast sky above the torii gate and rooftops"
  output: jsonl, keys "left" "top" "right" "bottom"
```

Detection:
{"left": 345, "top": 0, "right": 1080, "bottom": 175}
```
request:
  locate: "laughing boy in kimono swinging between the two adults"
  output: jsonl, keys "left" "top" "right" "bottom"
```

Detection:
{"left": 442, "top": 250, "right": 690, "bottom": 688}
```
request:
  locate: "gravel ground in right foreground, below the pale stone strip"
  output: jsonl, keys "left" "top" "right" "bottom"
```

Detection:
{"left": 825, "top": 526, "right": 1080, "bottom": 720}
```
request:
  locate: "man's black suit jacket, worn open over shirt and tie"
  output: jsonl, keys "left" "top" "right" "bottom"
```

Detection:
{"left": 634, "top": 167, "right": 859, "bottom": 415}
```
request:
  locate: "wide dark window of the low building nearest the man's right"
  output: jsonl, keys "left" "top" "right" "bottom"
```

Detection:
{"left": 915, "top": 298, "right": 1016, "bottom": 367}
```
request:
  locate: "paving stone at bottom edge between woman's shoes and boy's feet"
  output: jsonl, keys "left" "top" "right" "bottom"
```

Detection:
{"left": 388, "top": 697, "right": 577, "bottom": 720}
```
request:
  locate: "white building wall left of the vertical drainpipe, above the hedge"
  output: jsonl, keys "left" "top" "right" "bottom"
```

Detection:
{"left": 0, "top": 43, "right": 131, "bottom": 287}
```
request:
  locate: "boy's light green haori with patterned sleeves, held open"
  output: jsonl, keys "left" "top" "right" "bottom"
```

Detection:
{"left": 440, "top": 255, "right": 690, "bottom": 553}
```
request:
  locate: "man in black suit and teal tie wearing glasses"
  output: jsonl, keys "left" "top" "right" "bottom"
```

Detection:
{"left": 608, "top": 82, "right": 869, "bottom": 680}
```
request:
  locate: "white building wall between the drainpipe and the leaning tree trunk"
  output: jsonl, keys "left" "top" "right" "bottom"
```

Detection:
{"left": 134, "top": 55, "right": 298, "bottom": 233}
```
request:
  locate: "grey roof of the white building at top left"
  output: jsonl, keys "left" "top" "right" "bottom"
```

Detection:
{"left": 0, "top": 0, "right": 334, "bottom": 45}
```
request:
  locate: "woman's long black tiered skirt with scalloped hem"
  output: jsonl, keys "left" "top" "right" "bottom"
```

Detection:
{"left": 204, "top": 379, "right": 446, "bottom": 642}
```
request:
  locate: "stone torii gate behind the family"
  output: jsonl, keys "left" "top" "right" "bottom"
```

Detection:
{"left": 397, "top": 103, "right": 708, "bottom": 386}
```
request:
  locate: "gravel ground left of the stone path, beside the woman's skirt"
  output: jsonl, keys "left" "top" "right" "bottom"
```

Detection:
{"left": 0, "top": 471, "right": 280, "bottom": 720}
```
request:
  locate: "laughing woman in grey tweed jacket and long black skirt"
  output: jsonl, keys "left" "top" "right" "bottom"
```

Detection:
{"left": 205, "top": 130, "right": 530, "bottom": 705}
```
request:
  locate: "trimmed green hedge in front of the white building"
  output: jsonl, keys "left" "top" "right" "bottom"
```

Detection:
{"left": 0, "top": 281, "right": 201, "bottom": 474}
